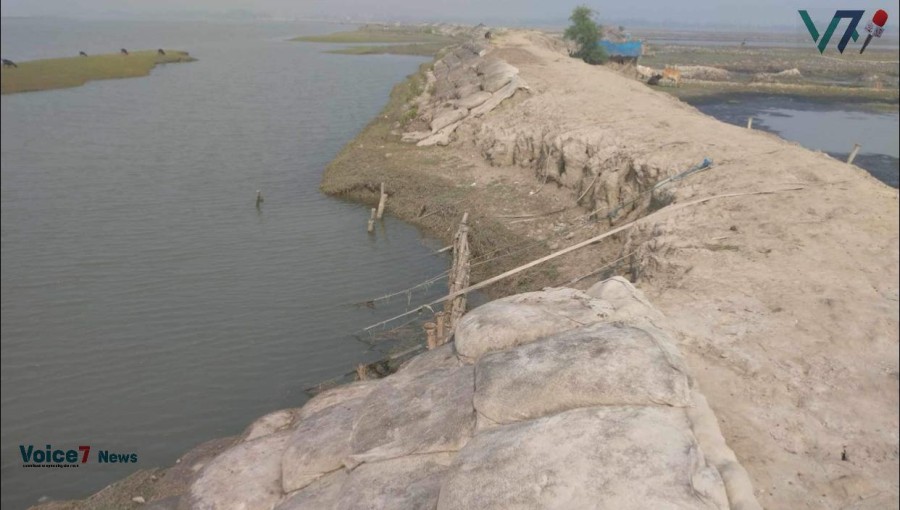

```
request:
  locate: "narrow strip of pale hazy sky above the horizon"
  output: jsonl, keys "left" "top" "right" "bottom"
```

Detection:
{"left": 0, "top": 0, "right": 900, "bottom": 28}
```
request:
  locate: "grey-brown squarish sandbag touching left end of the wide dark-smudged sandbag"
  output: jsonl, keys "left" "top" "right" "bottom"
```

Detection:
{"left": 345, "top": 365, "right": 475, "bottom": 467}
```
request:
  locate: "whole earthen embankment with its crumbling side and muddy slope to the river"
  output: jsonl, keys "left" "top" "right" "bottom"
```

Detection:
{"left": 323, "top": 32, "right": 900, "bottom": 509}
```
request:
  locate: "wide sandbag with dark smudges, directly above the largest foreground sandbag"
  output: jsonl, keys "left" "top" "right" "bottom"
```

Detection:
{"left": 474, "top": 323, "right": 691, "bottom": 423}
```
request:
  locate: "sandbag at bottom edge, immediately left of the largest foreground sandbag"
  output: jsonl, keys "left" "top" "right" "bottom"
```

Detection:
{"left": 334, "top": 453, "right": 453, "bottom": 510}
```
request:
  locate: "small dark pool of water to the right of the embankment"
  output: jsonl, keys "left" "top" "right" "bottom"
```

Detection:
{"left": 692, "top": 94, "right": 900, "bottom": 188}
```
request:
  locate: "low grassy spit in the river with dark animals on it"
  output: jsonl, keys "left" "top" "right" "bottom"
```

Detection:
{"left": 0, "top": 50, "right": 196, "bottom": 94}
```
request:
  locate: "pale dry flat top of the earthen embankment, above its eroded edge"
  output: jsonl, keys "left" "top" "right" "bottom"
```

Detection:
{"left": 478, "top": 34, "right": 898, "bottom": 509}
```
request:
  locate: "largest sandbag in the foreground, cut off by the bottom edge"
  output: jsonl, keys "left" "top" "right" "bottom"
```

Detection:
{"left": 438, "top": 406, "right": 728, "bottom": 510}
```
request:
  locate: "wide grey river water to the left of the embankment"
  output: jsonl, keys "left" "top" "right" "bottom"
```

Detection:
{"left": 0, "top": 19, "right": 447, "bottom": 509}
